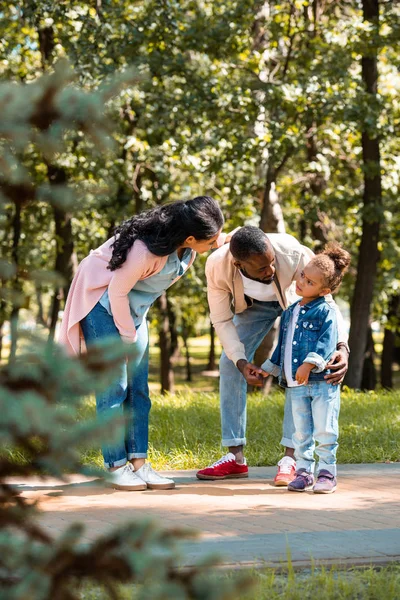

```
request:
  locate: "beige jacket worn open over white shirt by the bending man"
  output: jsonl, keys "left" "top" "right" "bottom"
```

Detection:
{"left": 206, "top": 233, "right": 347, "bottom": 364}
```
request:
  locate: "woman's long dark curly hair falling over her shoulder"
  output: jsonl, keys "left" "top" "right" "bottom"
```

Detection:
{"left": 108, "top": 196, "right": 224, "bottom": 271}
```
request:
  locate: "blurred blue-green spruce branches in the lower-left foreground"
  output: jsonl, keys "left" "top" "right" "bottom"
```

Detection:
{"left": 0, "top": 341, "right": 253, "bottom": 600}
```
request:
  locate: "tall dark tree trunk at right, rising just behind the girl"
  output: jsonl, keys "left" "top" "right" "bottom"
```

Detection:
{"left": 345, "top": 0, "right": 382, "bottom": 388}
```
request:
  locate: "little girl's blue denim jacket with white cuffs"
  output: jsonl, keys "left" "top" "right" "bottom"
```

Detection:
{"left": 261, "top": 296, "right": 338, "bottom": 387}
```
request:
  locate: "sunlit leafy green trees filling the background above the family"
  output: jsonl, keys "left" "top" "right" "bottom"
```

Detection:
{"left": 0, "top": 0, "right": 400, "bottom": 370}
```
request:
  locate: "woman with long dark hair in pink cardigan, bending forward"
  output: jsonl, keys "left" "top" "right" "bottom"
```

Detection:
{"left": 60, "top": 196, "right": 230, "bottom": 490}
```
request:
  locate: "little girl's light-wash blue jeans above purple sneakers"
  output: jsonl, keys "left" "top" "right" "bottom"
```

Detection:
{"left": 286, "top": 381, "right": 340, "bottom": 475}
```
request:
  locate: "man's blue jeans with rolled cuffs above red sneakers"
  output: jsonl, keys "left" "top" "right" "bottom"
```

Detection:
{"left": 219, "top": 300, "right": 294, "bottom": 448}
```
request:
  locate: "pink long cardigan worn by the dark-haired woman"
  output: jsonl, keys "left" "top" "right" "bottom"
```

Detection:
{"left": 59, "top": 234, "right": 195, "bottom": 354}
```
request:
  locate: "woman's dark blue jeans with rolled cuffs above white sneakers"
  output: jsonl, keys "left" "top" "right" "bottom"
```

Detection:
{"left": 80, "top": 303, "right": 151, "bottom": 468}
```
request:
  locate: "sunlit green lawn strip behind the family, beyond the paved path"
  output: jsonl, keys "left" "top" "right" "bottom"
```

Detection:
{"left": 80, "top": 389, "right": 400, "bottom": 469}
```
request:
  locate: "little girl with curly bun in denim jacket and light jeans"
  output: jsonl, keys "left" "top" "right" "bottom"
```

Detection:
{"left": 261, "top": 243, "right": 350, "bottom": 494}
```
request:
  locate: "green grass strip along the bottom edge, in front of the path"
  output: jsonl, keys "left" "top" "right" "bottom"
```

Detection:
{"left": 81, "top": 565, "right": 400, "bottom": 600}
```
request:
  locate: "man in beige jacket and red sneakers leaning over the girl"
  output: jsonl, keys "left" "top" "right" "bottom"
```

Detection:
{"left": 197, "top": 226, "right": 349, "bottom": 486}
